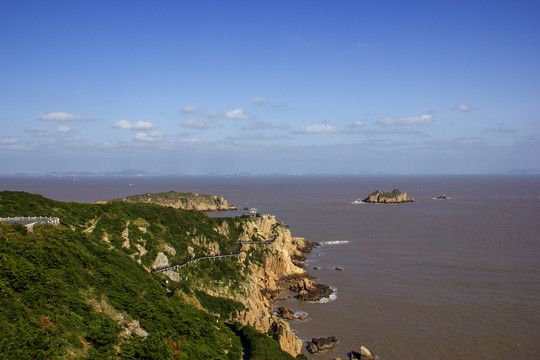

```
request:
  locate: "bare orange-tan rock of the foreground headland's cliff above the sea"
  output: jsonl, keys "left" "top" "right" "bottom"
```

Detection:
{"left": 156, "top": 215, "right": 309, "bottom": 356}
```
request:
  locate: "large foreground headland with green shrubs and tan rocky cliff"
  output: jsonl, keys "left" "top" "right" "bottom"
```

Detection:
{"left": 0, "top": 191, "right": 305, "bottom": 359}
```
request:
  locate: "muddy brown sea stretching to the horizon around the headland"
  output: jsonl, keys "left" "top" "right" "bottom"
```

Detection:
{"left": 0, "top": 176, "right": 540, "bottom": 360}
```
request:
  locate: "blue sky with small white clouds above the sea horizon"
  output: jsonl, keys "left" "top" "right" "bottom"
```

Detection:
{"left": 0, "top": 0, "right": 540, "bottom": 174}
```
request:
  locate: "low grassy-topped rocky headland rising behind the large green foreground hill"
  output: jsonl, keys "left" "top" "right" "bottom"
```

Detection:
{"left": 95, "top": 191, "right": 236, "bottom": 211}
